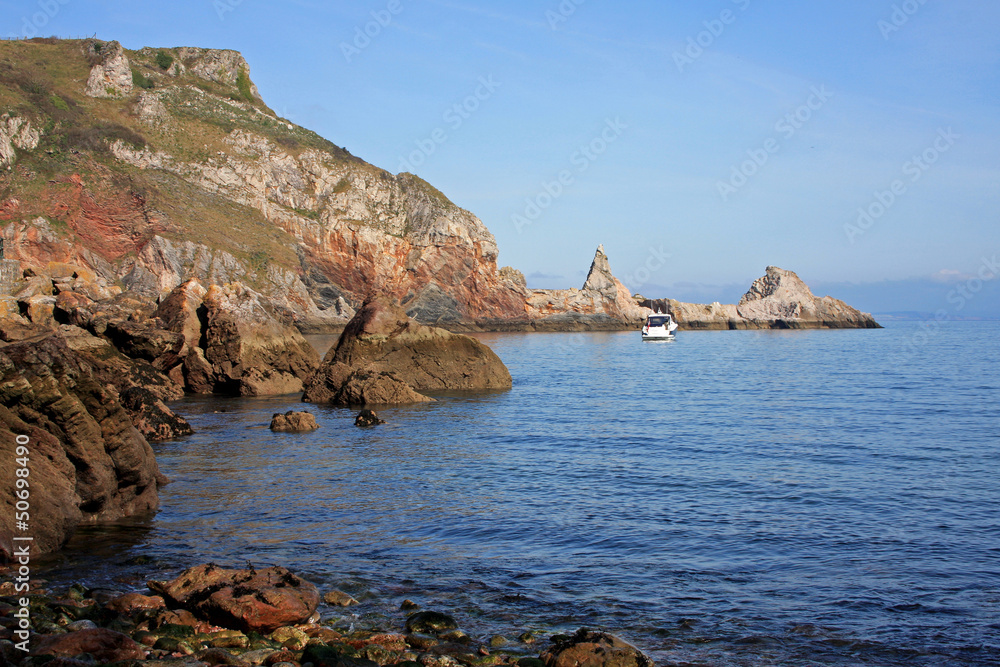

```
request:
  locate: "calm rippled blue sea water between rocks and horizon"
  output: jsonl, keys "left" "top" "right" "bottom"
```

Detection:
{"left": 39, "top": 323, "right": 1000, "bottom": 665}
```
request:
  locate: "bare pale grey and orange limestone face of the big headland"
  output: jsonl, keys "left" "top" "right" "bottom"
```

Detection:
{"left": 112, "top": 130, "right": 524, "bottom": 323}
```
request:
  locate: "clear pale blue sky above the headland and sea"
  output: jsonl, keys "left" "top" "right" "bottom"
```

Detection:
{"left": 0, "top": 0, "right": 1000, "bottom": 315}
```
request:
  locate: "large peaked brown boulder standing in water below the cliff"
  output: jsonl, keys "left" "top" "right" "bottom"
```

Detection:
{"left": 303, "top": 296, "right": 511, "bottom": 405}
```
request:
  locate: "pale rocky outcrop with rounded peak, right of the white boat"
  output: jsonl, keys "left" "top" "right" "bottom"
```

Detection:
{"left": 641, "top": 266, "right": 879, "bottom": 329}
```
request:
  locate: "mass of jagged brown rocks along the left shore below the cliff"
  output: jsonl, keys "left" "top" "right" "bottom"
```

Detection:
{"left": 0, "top": 263, "right": 319, "bottom": 561}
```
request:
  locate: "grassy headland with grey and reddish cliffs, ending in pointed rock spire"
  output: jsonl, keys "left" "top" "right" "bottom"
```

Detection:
{"left": 0, "top": 39, "right": 870, "bottom": 334}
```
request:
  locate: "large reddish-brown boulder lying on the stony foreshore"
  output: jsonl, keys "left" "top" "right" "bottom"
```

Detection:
{"left": 149, "top": 564, "right": 320, "bottom": 633}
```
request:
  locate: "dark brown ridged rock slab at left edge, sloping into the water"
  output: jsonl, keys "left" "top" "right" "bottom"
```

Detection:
{"left": 0, "top": 327, "right": 162, "bottom": 559}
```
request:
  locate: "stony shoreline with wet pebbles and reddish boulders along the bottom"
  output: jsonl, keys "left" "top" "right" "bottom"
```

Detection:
{"left": 0, "top": 564, "right": 653, "bottom": 667}
